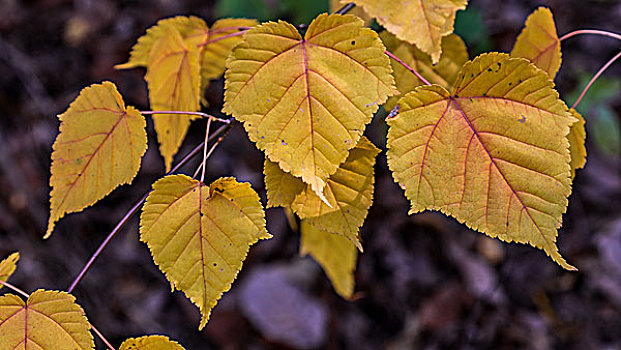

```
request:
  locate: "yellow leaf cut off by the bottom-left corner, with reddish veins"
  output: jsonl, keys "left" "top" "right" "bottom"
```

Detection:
{"left": 0, "top": 290, "right": 95, "bottom": 350}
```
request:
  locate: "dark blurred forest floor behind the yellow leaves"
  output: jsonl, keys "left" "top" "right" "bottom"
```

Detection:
{"left": 0, "top": 0, "right": 621, "bottom": 350}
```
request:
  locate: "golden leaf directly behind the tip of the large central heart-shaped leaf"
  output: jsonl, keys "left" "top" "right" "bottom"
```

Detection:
{"left": 265, "top": 136, "right": 379, "bottom": 247}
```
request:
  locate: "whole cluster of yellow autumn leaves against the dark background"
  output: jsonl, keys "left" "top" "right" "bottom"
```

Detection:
{"left": 0, "top": 0, "right": 586, "bottom": 349}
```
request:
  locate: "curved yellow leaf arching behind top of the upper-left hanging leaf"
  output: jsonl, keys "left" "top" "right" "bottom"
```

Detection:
{"left": 114, "top": 16, "right": 209, "bottom": 69}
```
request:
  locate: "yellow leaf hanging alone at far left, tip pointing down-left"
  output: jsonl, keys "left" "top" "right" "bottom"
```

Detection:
{"left": 45, "top": 81, "right": 147, "bottom": 238}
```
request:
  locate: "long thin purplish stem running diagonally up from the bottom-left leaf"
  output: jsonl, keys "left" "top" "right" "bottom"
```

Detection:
{"left": 67, "top": 120, "right": 233, "bottom": 293}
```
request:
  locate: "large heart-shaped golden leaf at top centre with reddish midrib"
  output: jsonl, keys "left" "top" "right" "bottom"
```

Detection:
{"left": 223, "top": 14, "right": 396, "bottom": 195}
